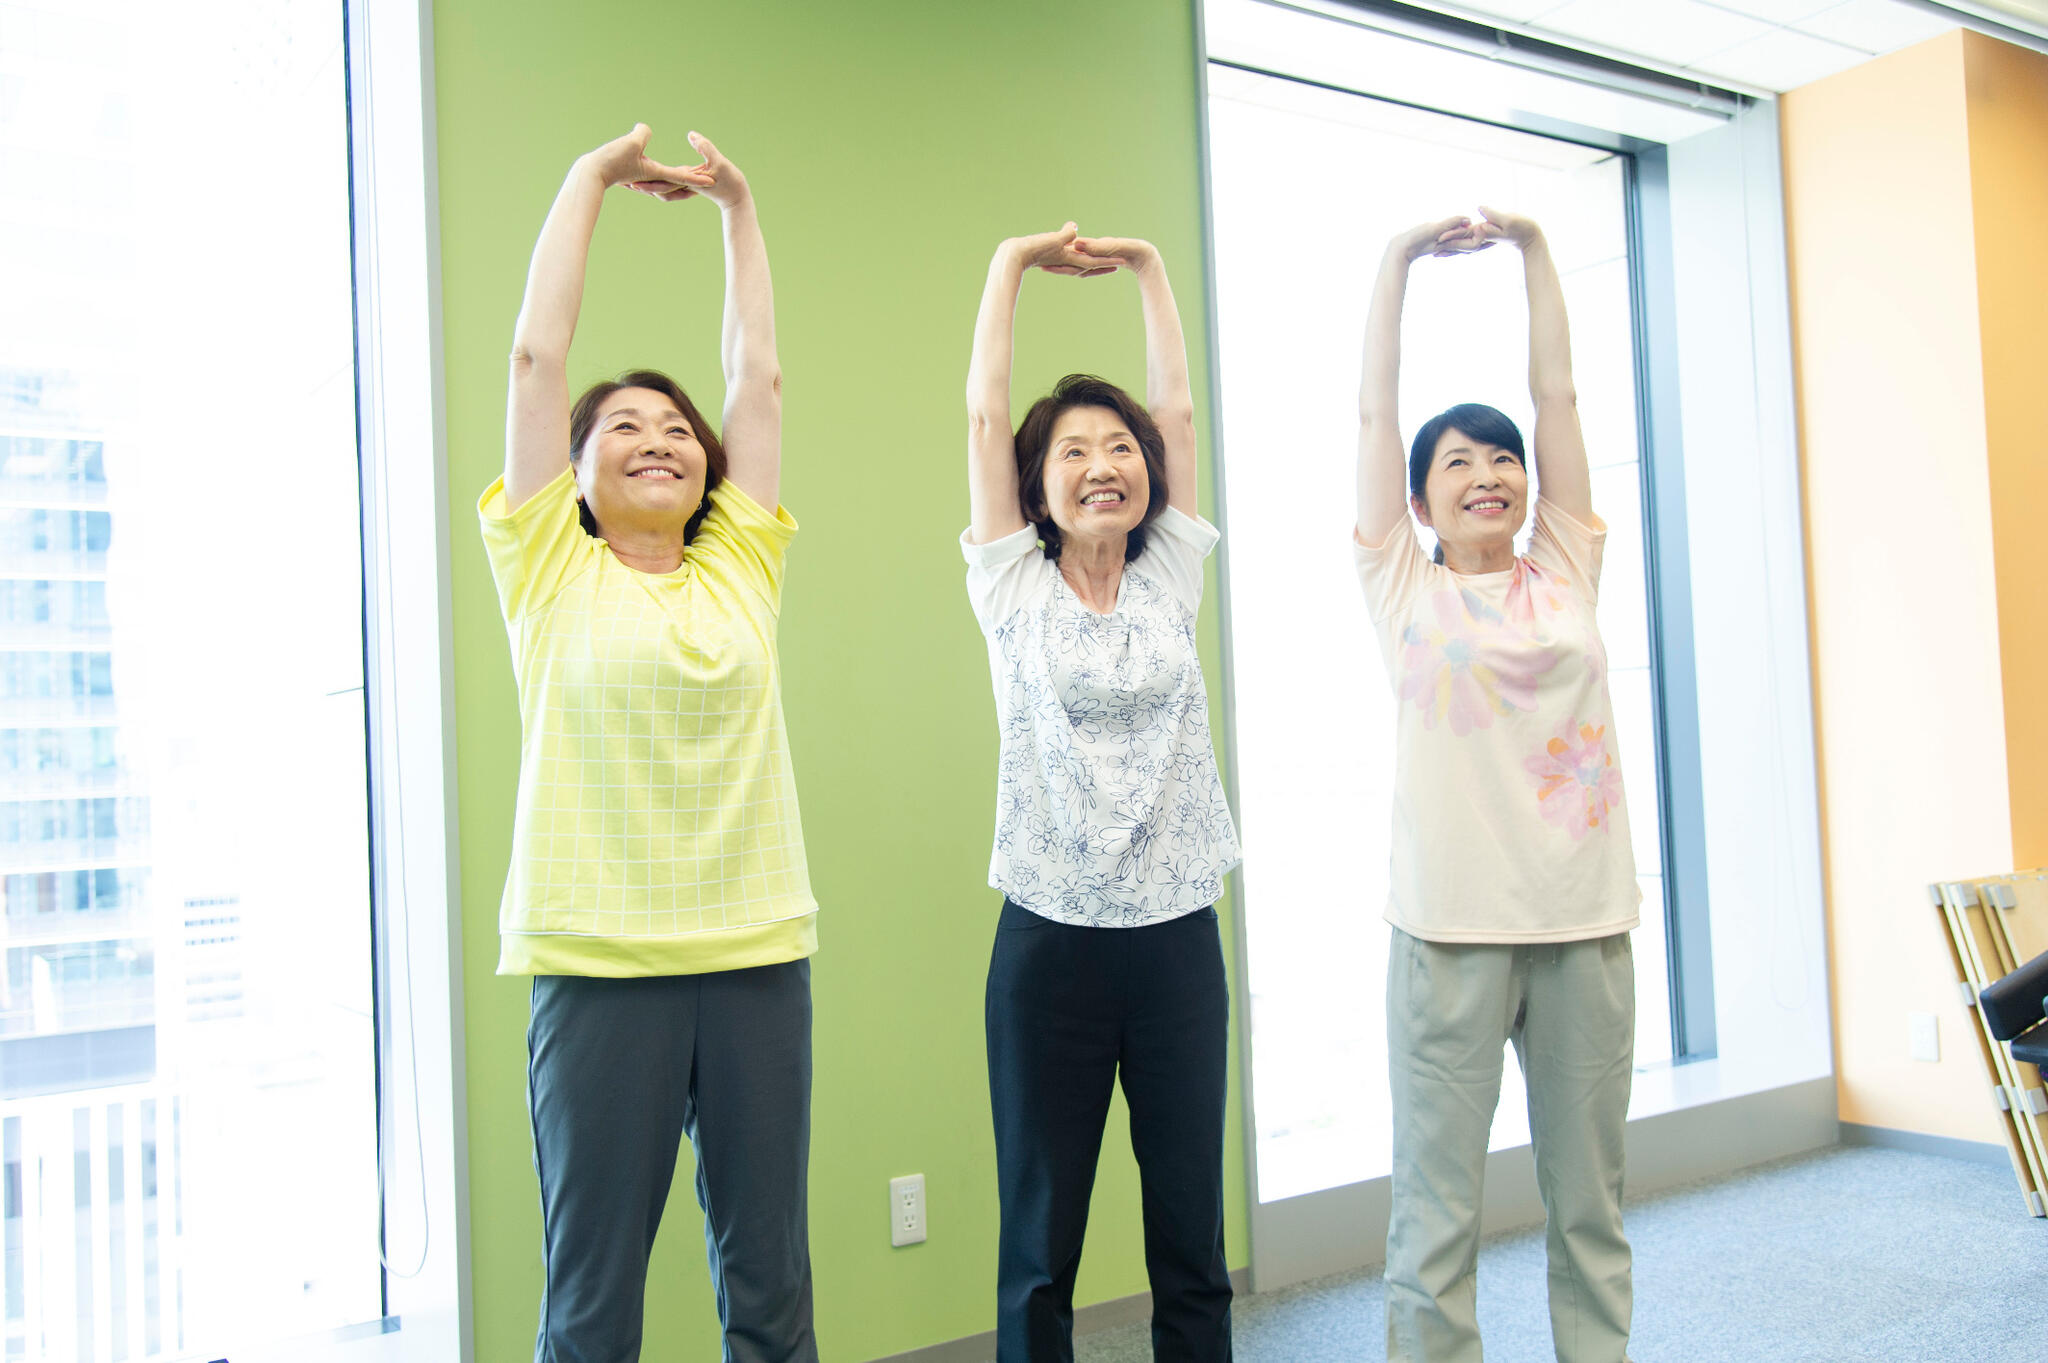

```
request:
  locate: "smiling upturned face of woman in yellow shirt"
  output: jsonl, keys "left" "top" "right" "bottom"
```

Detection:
{"left": 575, "top": 389, "right": 707, "bottom": 532}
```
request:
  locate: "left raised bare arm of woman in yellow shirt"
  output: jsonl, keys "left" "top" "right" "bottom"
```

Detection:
{"left": 506, "top": 123, "right": 702, "bottom": 510}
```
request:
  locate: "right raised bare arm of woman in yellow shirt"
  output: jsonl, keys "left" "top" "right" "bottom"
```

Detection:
{"left": 690, "top": 133, "right": 782, "bottom": 512}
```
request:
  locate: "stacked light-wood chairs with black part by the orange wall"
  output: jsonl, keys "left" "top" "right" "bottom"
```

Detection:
{"left": 1927, "top": 870, "right": 2048, "bottom": 1216}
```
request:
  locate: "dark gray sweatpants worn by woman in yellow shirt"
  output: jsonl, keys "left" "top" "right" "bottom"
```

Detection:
{"left": 526, "top": 960, "right": 817, "bottom": 1363}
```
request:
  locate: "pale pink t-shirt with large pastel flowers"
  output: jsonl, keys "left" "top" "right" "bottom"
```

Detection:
{"left": 1352, "top": 497, "right": 1642, "bottom": 941}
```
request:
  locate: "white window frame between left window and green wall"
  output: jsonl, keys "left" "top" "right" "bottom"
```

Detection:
{"left": 292, "top": 0, "right": 473, "bottom": 1363}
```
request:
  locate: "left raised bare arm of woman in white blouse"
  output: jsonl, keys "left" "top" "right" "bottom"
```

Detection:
{"left": 967, "top": 223, "right": 1114, "bottom": 544}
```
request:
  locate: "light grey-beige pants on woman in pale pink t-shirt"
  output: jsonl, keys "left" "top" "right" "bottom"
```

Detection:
{"left": 1386, "top": 929, "right": 1636, "bottom": 1363}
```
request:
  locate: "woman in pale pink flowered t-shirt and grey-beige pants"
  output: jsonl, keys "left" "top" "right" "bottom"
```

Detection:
{"left": 1354, "top": 209, "right": 1640, "bottom": 1363}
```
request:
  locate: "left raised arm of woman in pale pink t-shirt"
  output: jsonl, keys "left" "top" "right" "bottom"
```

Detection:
{"left": 1356, "top": 217, "right": 1485, "bottom": 546}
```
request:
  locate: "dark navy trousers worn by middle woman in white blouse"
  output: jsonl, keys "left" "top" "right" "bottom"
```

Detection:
{"left": 987, "top": 900, "right": 1231, "bottom": 1363}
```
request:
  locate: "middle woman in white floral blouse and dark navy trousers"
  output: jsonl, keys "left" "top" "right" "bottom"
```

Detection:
{"left": 961, "top": 223, "right": 1237, "bottom": 1363}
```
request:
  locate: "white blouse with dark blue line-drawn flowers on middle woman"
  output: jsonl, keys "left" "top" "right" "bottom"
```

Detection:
{"left": 961, "top": 508, "right": 1237, "bottom": 927}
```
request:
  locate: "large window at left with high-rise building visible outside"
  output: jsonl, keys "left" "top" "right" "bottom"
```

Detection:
{"left": 0, "top": 0, "right": 385, "bottom": 1361}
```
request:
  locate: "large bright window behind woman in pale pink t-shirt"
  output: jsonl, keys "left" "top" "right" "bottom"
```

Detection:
{"left": 1208, "top": 68, "right": 1673, "bottom": 1201}
